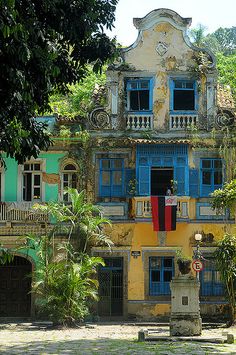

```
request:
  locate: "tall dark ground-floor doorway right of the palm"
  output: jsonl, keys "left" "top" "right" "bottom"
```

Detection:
{"left": 98, "top": 257, "right": 124, "bottom": 317}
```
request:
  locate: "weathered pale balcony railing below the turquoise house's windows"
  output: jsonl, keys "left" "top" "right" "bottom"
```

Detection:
{"left": 0, "top": 202, "right": 49, "bottom": 222}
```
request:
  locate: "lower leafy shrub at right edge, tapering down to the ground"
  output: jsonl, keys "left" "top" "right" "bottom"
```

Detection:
{"left": 215, "top": 234, "right": 236, "bottom": 322}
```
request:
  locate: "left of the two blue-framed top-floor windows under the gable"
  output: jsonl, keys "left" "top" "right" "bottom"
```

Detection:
{"left": 126, "top": 78, "right": 152, "bottom": 113}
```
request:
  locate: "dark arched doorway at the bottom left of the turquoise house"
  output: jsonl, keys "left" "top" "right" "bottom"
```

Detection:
{"left": 0, "top": 256, "right": 32, "bottom": 317}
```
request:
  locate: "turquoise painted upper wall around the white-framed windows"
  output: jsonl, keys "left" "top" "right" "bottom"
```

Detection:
{"left": 4, "top": 153, "right": 66, "bottom": 202}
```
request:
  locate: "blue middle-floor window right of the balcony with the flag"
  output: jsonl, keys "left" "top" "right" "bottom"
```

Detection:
{"left": 200, "top": 159, "right": 223, "bottom": 196}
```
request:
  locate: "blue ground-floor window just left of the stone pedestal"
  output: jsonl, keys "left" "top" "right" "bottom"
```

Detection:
{"left": 149, "top": 256, "right": 174, "bottom": 296}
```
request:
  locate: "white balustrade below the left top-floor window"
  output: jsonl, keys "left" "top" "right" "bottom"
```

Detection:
{"left": 126, "top": 114, "right": 153, "bottom": 131}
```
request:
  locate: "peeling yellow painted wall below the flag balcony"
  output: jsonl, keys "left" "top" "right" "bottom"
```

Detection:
{"left": 105, "top": 221, "right": 230, "bottom": 308}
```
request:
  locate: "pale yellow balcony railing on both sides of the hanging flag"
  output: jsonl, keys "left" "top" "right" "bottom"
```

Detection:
{"left": 133, "top": 196, "right": 189, "bottom": 219}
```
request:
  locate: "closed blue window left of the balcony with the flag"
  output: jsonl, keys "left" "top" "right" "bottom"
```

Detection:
{"left": 99, "top": 158, "right": 124, "bottom": 197}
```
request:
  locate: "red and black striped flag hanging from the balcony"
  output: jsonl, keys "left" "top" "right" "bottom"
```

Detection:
{"left": 151, "top": 196, "right": 177, "bottom": 231}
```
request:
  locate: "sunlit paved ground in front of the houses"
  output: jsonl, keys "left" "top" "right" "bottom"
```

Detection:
{"left": 0, "top": 324, "right": 236, "bottom": 355}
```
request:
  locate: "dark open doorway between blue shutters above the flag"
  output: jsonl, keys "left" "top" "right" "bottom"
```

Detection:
{"left": 151, "top": 167, "right": 174, "bottom": 196}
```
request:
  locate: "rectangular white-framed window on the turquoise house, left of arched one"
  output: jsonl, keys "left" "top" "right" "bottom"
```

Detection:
{"left": 23, "top": 162, "right": 42, "bottom": 201}
